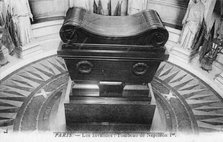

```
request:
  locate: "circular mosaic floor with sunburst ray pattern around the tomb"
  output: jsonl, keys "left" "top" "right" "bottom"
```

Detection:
{"left": 0, "top": 56, "right": 223, "bottom": 133}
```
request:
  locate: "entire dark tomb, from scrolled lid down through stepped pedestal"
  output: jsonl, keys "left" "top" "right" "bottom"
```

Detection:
{"left": 58, "top": 8, "right": 168, "bottom": 131}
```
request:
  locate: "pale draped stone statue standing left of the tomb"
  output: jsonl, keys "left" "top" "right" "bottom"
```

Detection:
{"left": 7, "top": 0, "right": 33, "bottom": 46}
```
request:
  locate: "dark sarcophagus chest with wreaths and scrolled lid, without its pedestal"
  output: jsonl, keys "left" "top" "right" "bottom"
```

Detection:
{"left": 58, "top": 8, "right": 168, "bottom": 84}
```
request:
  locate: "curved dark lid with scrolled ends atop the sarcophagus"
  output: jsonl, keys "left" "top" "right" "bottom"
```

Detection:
{"left": 60, "top": 7, "right": 169, "bottom": 46}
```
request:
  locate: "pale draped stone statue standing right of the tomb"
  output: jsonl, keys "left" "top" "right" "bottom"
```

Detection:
{"left": 179, "top": 0, "right": 206, "bottom": 50}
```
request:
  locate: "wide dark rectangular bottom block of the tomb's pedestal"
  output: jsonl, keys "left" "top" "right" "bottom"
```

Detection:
{"left": 65, "top": 97, "right": 156, "bottom": 131}
